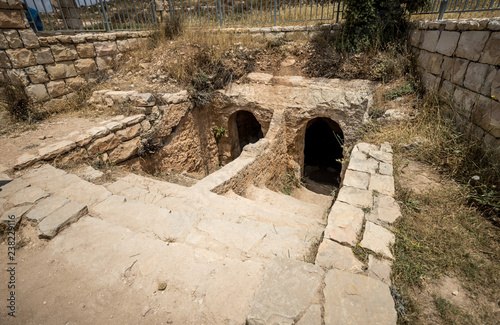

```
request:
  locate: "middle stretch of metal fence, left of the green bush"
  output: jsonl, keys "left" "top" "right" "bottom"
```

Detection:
{"left": 168, "top": 0, "right": 344, "bottom": 28}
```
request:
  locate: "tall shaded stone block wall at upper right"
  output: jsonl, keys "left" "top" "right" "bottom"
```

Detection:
{"left": 410, "top": 19, "right": 500, "bottom": 150}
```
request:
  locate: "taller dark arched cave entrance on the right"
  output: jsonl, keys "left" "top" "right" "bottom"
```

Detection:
{"left": 303, "top": 117, "right": 344, "bottom": 195}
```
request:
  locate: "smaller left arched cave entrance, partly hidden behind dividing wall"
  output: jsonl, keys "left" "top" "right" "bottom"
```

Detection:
{"left": 230, "top": 111, "right": 264, "bottom": 159}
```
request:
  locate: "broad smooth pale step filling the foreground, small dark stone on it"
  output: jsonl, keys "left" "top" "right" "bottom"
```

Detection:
{"left": 27, "top": 216, "right": 266, "bottom": 324}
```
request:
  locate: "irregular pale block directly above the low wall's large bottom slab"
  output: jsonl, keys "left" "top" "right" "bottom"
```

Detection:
{"left": 315, "top": 239, "right": 363, "bottom": 273}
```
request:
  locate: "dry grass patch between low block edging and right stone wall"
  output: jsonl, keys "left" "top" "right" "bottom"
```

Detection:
{"left": 363, "top": 86, "right": 500, "bottom": 324}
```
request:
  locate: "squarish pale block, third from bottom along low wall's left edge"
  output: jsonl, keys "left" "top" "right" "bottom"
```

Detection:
{"left": 325, "top": 201, "right": 364, "bottom": 245}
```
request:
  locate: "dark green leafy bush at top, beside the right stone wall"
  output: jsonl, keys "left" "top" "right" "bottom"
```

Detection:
{"left": 338, "top": 0, "right": 429, "bottom": 52}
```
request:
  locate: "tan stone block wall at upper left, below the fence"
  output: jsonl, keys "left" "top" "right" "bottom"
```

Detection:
{"left": 0, "top": 0, "right": 150, "bottom": 103}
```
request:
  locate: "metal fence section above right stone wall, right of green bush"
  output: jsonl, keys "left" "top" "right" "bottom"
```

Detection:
{"left": 414, "top": 0, "right": 500, "bottom": 20}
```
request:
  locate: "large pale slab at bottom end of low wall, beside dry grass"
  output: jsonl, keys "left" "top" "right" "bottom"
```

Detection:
{"left": 323, "top": 269, "right": 397, "bottom": 325}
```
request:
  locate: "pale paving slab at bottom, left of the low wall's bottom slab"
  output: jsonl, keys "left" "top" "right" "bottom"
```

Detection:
{"left": 246, "top": 258, "right": 324, "bottom": 325}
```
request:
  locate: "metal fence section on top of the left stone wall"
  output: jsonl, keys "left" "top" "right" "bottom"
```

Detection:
{"left": 23, "top": 0, "right": 157, "bottom": 32}
